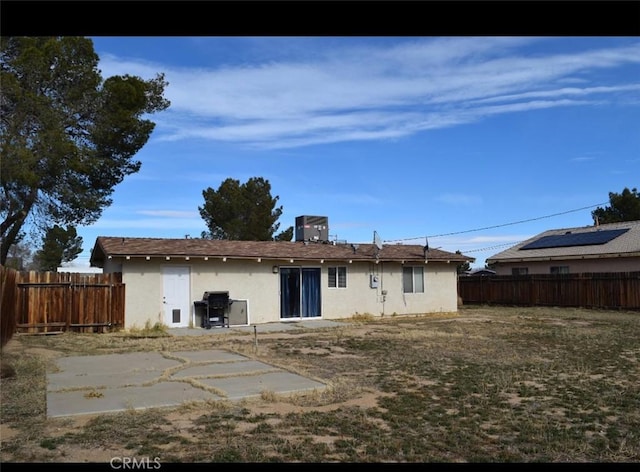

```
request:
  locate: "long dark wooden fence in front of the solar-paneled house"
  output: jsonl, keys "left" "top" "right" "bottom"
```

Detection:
{"left": 458, "top": 272, "right": 640, "bottom": 310}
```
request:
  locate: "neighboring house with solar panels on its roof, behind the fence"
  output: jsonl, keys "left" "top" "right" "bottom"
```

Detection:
{"left": 486, "top": 221, "right": 640, "bottom": 275}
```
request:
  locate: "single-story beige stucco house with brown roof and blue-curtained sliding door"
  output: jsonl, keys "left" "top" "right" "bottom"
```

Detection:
{"left": 91, "top": 228, "right": 474, "bottom": 328}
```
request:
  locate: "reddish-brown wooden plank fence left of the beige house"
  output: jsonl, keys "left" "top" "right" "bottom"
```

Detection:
{"left": 2, "top": 269, "right": 125, "bottom": 334}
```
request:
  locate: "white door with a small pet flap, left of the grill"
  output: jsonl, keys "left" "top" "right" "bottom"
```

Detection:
{"left": 162, "top": 266, "right": 191, "bottom": 328}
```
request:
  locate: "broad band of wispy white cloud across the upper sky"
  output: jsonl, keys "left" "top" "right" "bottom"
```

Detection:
{"left": 100, "top": 38, "right": 640, "bottom": 148}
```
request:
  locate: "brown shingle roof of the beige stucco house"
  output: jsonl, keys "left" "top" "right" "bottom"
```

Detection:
{"left": 91, "top": 236, "right": 474, "bottom": 267}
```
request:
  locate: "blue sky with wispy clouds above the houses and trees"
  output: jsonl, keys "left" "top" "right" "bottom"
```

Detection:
{"left": 67, "top": 36, "right": 640, "bottom": 267}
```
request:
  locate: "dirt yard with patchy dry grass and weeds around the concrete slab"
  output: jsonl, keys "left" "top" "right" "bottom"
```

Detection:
{"left": 0, "top": 307, "right": 640, "bottom": 463}
